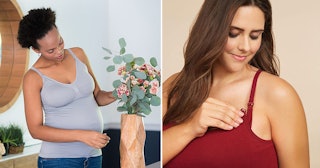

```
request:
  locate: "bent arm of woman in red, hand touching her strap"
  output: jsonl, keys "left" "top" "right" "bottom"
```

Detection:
{"left": 162, "top": 76, "right": 244, "bottom": 165}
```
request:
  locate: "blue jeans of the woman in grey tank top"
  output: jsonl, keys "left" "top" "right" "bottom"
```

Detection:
{"left": 38, "top": 156, "right": 102, "bottom": 168}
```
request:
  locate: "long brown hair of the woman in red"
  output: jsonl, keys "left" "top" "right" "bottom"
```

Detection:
{"left": 163, "top": 0, "right": 279, "bottom": 124}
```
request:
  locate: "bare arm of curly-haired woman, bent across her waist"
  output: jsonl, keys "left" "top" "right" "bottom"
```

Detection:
{"left": 23, "top": 70, "right": 110, "bottom": 148}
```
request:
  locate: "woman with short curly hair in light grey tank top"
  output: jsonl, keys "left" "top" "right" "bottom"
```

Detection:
{"left": 17, "top": 8, "right": 115, "bottom": 168}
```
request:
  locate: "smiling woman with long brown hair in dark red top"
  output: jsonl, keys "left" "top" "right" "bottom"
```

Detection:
{"left": 162, "top": 0, "right": 309, "bottom": 168}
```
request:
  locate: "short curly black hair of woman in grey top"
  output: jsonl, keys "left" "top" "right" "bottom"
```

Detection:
{"left": 17, "top": 8, "right": 57, "bottom": 49}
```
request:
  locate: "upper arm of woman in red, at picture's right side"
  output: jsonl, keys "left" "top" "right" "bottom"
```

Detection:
{"left": 269, "top": 79, "right": 310, "bottom": 168}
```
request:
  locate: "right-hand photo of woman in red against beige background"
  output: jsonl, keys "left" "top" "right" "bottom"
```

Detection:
{"left": 161, "top": 0, "right": 320, "bottom": 168}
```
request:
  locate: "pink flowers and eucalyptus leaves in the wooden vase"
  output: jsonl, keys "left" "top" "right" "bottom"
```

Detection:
{"left": 102, "top": 38, "right": 161, "bottom": 116}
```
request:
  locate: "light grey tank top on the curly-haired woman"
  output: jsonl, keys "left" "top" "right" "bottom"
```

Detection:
{"left": 31, "top": 49, "right": 103, "bottom": 158}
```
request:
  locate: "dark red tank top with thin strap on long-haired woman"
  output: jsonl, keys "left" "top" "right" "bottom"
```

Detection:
{"left": 163, "top": 70, "right": 278, "bottom": 168}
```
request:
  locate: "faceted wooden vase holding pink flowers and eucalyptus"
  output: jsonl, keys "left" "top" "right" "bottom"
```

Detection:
{"left": 103, "top": 38, "right": 161, "bottom": 168}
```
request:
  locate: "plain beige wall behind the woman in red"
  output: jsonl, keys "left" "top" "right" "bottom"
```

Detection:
{"left": 162, "top": 0, "right": 320, "bottom": 168}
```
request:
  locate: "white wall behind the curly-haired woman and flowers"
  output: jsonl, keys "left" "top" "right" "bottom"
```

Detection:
{"left": 0, "top": 0, "right": 161, "bottom": 145}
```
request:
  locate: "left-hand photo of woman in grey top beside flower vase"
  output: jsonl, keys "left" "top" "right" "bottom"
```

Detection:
{"left": 0, "top": 0, "right": 162, "bottom": 168}
